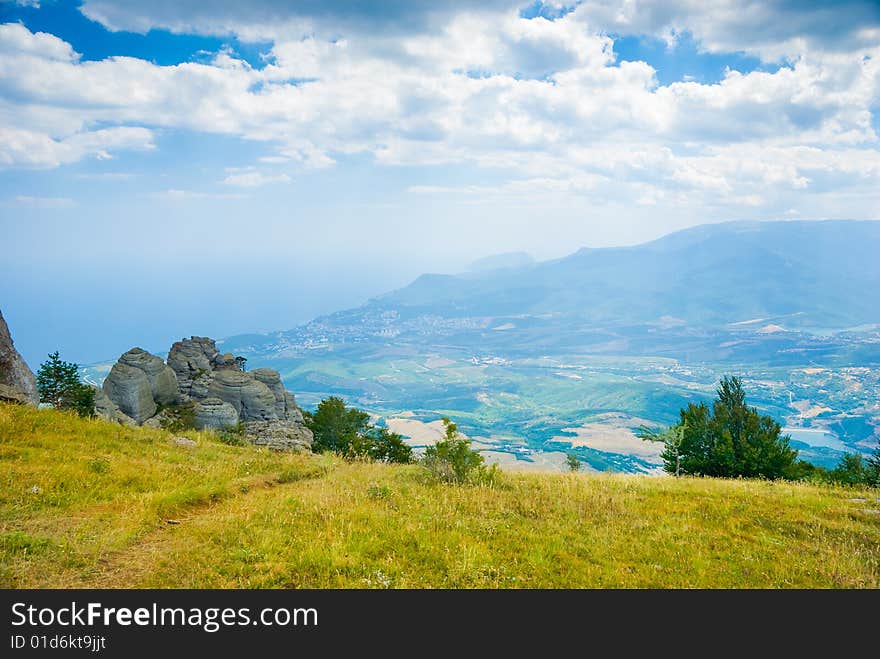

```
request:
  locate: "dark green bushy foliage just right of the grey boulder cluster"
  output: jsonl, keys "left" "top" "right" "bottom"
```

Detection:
{"left": 303, "top": 396, "right": 412, "bottom": 463}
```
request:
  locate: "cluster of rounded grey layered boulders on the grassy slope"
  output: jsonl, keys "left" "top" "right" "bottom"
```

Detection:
{"left": 95, "top": 336, "right": 312, "bottom": 449}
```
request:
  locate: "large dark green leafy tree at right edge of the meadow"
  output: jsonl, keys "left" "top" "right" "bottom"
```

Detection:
{"left": 643, "top": 376, "right": 797, "bottom": 479}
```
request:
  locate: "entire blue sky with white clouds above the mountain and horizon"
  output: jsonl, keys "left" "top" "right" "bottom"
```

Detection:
{"left": 0, "top": 0, "right": 880, "bottom": 369}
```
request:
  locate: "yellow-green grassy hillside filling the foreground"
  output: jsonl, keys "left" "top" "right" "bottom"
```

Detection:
{"left": 0, "top": 404, "right": 880, "bottom": 588}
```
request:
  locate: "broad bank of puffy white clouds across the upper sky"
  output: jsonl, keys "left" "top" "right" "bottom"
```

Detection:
{"left": 0, "top": 0, "right": 880, "bottom": 219}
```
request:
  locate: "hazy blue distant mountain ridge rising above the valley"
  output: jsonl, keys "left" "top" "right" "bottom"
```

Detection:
{"left": 376, "top": 221, "right": 880, "bottom": 328}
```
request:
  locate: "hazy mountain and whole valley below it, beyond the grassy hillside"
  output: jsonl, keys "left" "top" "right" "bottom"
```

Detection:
{"left": 84, "top": 221, "right": 880, "bottom": 472}
